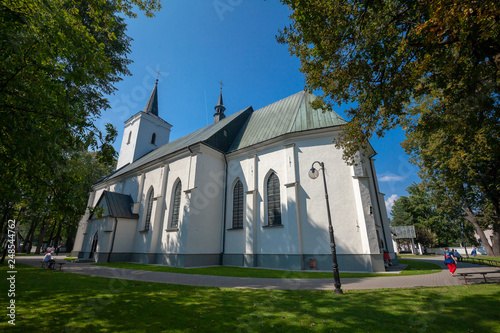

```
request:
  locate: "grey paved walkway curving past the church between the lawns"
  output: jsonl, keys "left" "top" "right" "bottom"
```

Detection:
{"left": 16, "top": 256, "right": 500, "bottom": 290}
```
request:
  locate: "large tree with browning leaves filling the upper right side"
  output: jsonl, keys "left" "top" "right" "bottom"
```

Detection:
{"left": 278, "top": 0, "right": 500, "bottom": 253}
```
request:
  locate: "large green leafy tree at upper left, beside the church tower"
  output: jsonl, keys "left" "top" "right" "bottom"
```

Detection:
{"left": 0, "top": 0, "right": 160, "bottom": 256}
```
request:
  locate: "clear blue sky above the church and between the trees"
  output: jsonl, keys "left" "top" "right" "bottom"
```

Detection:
{"left": 99, "top": 0, "right": 419, "bottom": 215}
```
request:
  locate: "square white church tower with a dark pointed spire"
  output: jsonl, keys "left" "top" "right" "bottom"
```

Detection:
{"left": 116, "top": 80, "right": 172, "bottom": 169}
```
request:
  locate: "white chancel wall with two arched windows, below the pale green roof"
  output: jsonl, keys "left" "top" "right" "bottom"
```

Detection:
{"left": 225, "top": 133, "right": 383, "bottom": 260}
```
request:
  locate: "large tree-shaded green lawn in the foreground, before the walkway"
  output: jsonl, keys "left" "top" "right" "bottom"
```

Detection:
{"left": 0, "top": 264, "right": 500, "bottom": 333}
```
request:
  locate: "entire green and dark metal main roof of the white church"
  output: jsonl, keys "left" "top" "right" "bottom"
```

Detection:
{"left": 96, "top": 91, "right": 346, "bottom": 184}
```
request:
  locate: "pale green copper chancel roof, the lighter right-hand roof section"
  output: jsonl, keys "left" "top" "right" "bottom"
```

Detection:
{"left": 229, "top": 91, "right": 347, "bottom": 152}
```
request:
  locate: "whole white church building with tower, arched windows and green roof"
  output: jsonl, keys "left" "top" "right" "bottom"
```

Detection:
{"left": 73, "top": 84, "right": 394, "bottom": 272}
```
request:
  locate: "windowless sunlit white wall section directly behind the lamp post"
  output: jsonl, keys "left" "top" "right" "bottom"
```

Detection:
{"left": 297, "top": 135, "right": 363, "bottom": 254}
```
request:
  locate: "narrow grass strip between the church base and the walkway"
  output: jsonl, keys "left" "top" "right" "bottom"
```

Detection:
{"left": 96, "top": 259, "right": 441, "bottom": 279}
